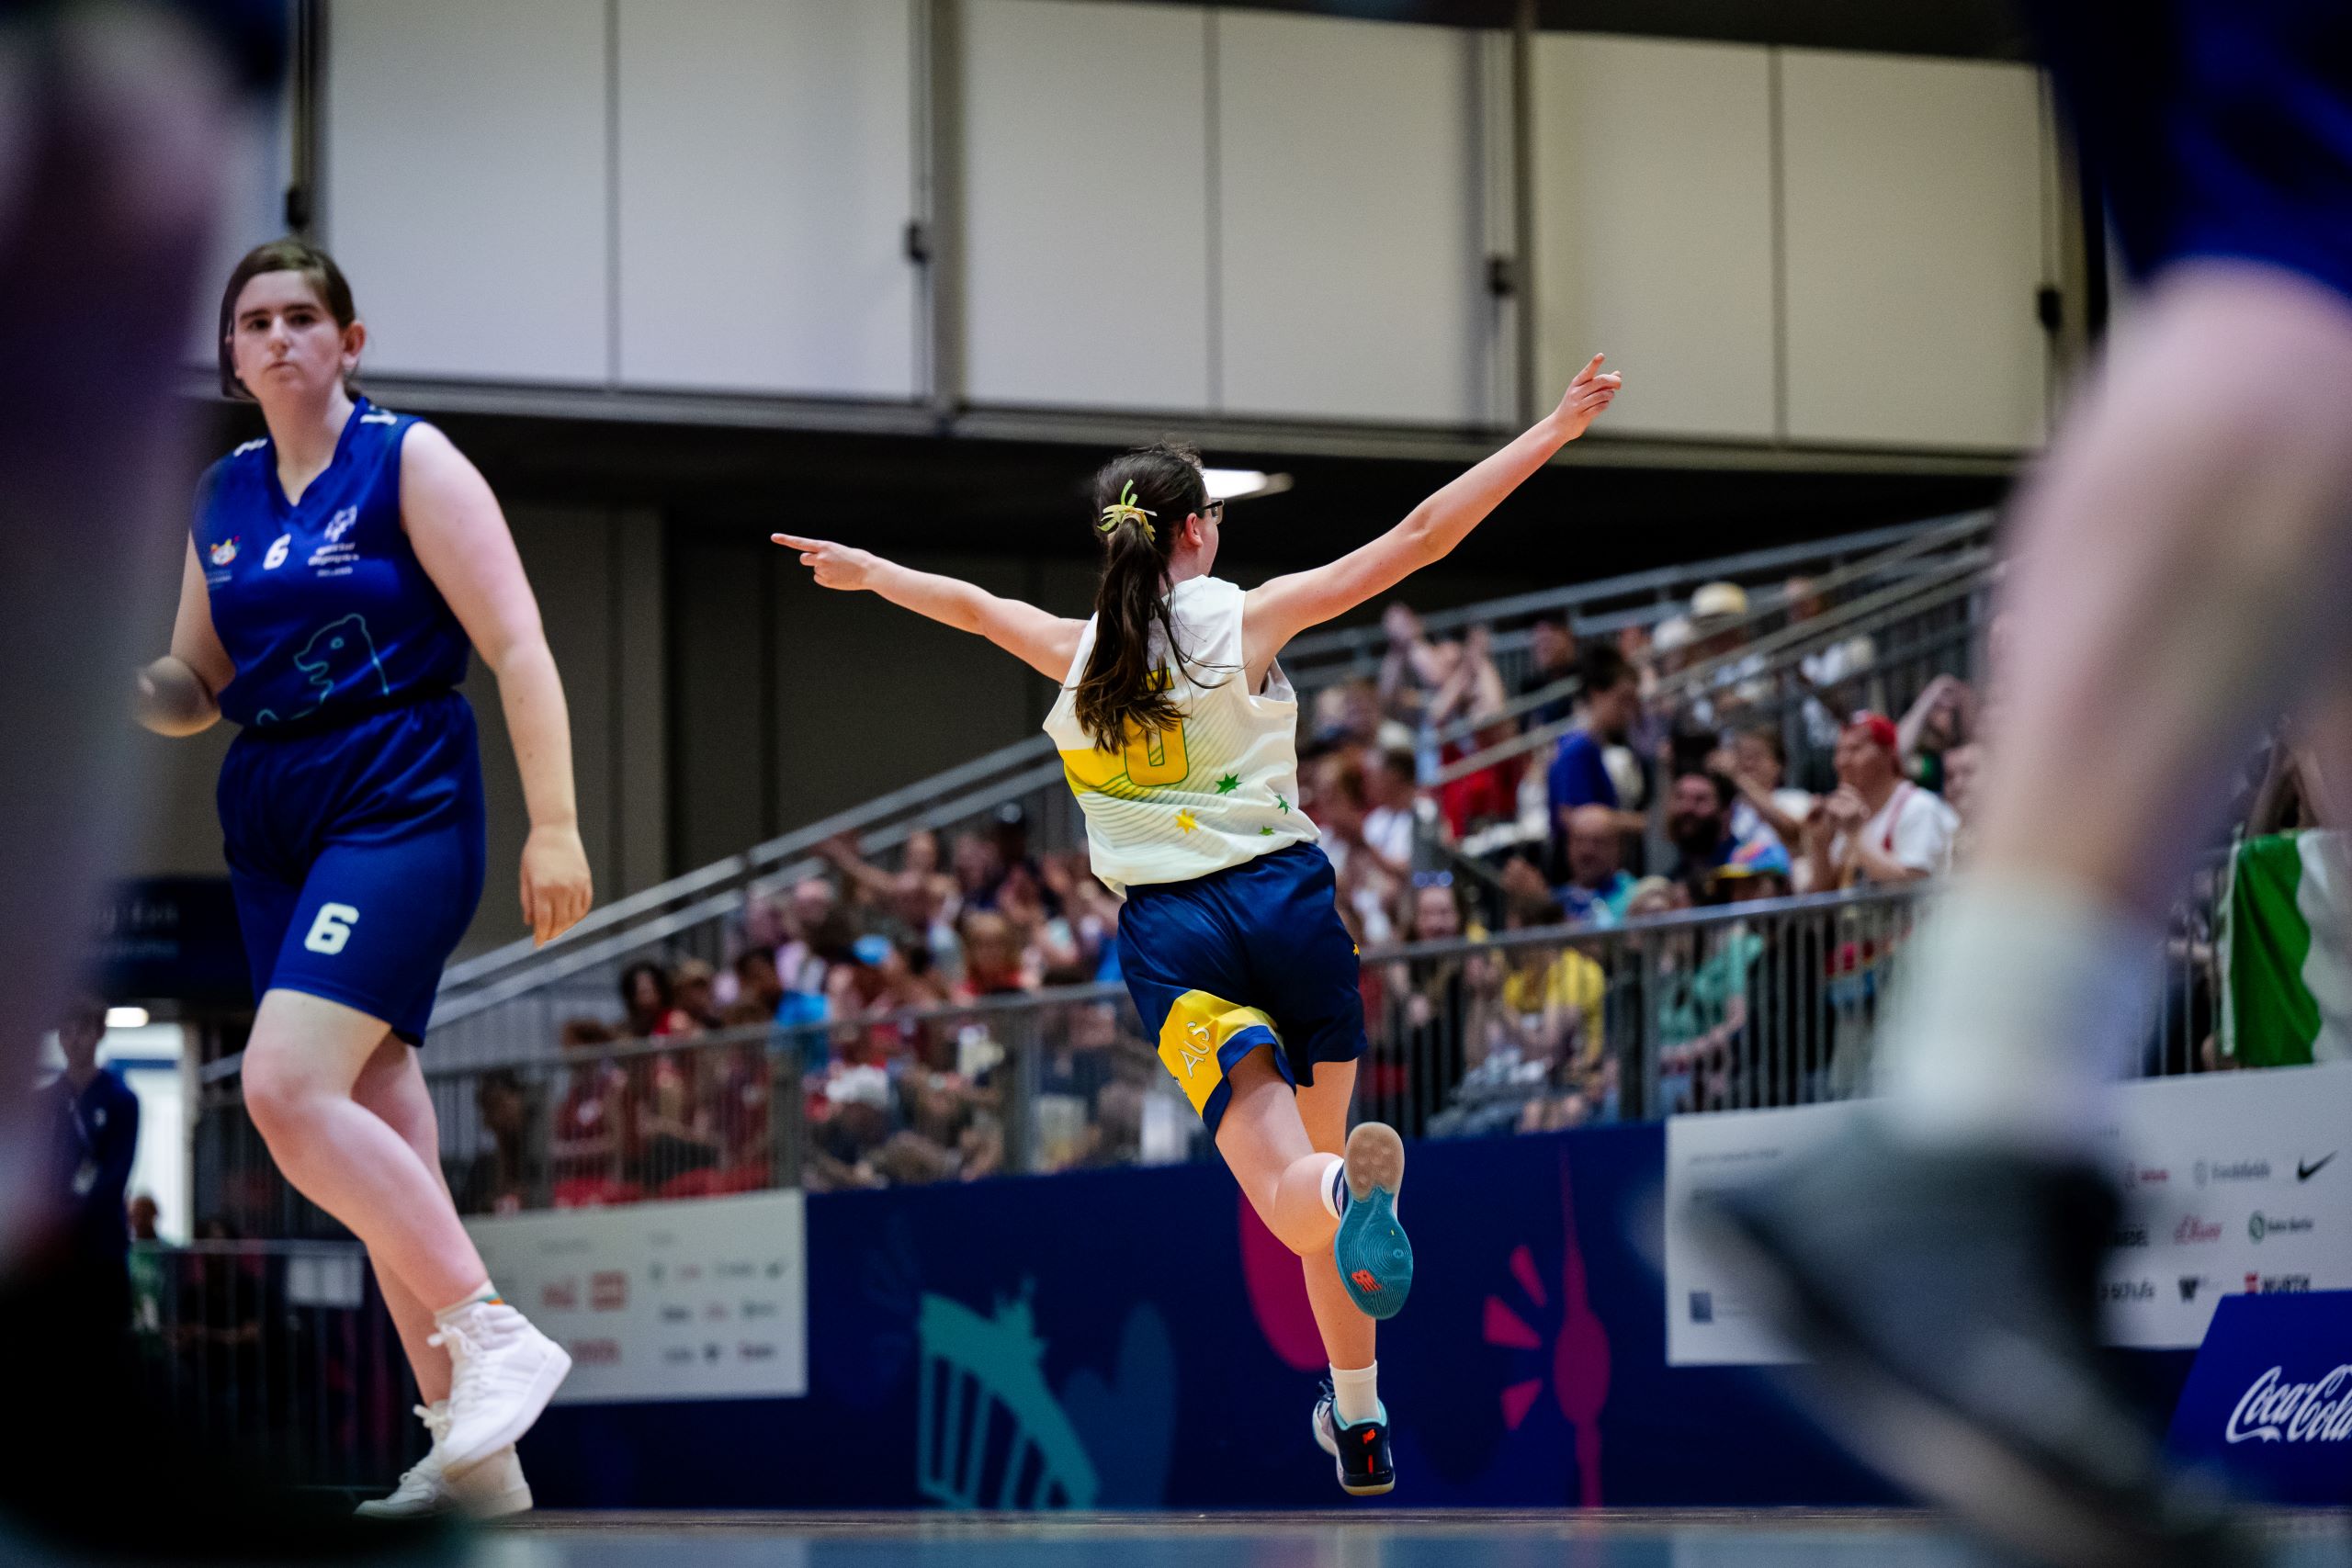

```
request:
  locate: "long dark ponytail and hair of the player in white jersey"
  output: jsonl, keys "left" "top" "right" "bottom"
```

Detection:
{"left": 1077, "top": 442, "right": 1209, "bottom": 752}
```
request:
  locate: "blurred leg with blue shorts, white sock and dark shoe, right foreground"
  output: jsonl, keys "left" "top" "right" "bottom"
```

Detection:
{"left": 1714, "top": 0, "right": 2352, "bottom": 1565}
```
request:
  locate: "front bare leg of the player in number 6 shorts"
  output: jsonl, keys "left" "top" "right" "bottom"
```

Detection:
{"left": 244, "top": 989, "right": 487, "bottom": 1309}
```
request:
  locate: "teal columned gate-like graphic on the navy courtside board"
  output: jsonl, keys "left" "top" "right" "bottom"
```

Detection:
{"left": 915, "top": 1288, "right": 1101, "bottom": 1509}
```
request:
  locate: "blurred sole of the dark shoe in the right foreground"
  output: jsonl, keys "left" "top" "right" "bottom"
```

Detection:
{"left": 1693, "top": 1206, "right": 2209, "bottom": 1568}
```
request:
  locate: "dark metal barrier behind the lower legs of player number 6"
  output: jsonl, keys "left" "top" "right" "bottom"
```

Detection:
{"left": 132, "top": 1241, "right": 425, "bottom": 1491}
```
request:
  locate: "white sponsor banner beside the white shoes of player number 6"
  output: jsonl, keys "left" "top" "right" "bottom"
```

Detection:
{"left": 466, "top": 1192, "right": 809, "bottom": 1404}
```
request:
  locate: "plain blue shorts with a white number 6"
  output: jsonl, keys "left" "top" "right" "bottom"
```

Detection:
{"left": 219, "top": 691, "right": 487, "bottom": 1046}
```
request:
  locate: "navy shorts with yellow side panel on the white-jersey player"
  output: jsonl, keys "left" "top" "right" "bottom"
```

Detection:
{"left": 1120, "top": 844, "right": 1364, "bottom": 1135}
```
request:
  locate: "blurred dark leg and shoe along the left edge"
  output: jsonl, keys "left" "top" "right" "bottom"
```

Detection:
{"left": 0, "top": 0, "right": 437, "bottom": 1561}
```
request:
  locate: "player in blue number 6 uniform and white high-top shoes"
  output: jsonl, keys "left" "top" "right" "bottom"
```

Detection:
{"left": 139, "top": 240, "right": 591, "bottom": 1512}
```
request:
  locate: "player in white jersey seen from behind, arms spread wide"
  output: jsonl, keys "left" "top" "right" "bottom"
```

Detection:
{"left": 774, "top": 355, "right": 1618, "bottom": 1495}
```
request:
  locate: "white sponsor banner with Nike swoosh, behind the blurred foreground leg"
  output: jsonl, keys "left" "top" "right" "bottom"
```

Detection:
{"left": 1665, "top": 1065, "right": 2352, "bottom": 1366}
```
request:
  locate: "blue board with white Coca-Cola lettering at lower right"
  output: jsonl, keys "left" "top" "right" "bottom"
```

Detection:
{"left": 2171, "top": 1281, "right": 2352, "bottom": 1506}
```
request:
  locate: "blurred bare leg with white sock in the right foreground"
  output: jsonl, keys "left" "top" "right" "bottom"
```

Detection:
{"left": 1886, "top": 261, "right": 2352, "bottom": 1147}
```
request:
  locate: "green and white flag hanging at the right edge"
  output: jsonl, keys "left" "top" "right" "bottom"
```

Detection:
{"left": 2221, "top": 832, "right": 2352, "bottom": 1067}
